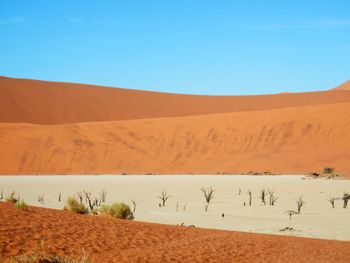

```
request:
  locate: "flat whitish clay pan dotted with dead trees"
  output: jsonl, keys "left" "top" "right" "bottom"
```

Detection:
{"left": 0, "top": 175, "right": 350, "bottom": 241}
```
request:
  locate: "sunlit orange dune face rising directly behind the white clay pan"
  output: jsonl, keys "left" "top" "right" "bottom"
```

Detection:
{"left": 0, "top": 103, "right": 350, "bottom": 175}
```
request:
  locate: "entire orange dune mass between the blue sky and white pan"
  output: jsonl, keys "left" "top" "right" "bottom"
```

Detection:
{"left": 0, "top": 77, "right": 350, "bottom": 175}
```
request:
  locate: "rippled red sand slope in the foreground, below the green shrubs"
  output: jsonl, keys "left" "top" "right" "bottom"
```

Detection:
{"left": 0, "top": 203, "right": 350, "bottom": 263}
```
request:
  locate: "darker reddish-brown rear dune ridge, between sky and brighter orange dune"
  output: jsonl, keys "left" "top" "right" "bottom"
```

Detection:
{"left": 0, "top": 77, "right": 350, "bottom": 124}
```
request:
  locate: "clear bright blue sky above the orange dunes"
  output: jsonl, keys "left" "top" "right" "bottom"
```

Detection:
{"left": 0, "top": 0, "right": 350, "bottom": 94}
